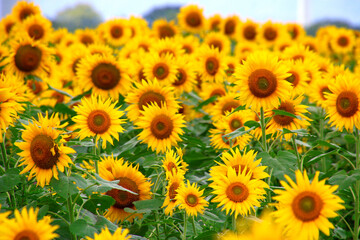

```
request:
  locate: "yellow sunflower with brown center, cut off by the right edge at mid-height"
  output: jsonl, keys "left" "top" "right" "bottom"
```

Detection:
{"left": 325, "top": 73, "right": 360, "bottom": 132}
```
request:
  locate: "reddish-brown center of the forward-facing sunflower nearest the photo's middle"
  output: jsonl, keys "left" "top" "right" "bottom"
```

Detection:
{"left": 150, "top": 114, "right": 174, "bottom": 139}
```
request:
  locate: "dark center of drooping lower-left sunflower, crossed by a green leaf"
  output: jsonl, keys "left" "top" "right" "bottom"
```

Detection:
{"left": 106, "top": 177, "right": 140, "bottom": 209}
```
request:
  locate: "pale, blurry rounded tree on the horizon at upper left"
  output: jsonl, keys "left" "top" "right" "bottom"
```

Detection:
{"left": 53, "top": 4, "right": 102, "bottom": 31}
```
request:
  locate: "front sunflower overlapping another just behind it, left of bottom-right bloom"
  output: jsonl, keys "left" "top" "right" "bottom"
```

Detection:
{"left": 211, "top": 167, "right": 267, "bottom": 218}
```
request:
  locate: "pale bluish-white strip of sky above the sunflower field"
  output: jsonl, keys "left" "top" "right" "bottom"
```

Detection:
{"left": 5, "top": 0, "right": 360, "bottom": 26}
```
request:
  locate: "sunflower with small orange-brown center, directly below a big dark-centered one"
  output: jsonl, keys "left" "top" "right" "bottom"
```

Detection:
{"left": 72, "top": 95, "right": 125, "bottom": 148}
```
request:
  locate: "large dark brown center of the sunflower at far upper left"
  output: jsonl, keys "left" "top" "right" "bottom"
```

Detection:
{"left": 15, "top": 44, "right": 42, "bottom": 72}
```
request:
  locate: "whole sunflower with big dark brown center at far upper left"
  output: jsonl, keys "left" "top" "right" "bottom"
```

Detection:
{"left": 5, "top": 35, "right": 51, "bottom": 78}
